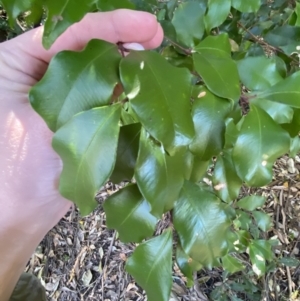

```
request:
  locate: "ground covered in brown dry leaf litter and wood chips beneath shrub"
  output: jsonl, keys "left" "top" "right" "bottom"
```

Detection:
{"left": 26, "top": 157, "right": 300, "bottom": 301}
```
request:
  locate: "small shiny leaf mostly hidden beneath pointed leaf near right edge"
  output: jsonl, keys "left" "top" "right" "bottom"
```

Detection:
{"left": 251, "top": 98, "right": 294, "bottom": 124}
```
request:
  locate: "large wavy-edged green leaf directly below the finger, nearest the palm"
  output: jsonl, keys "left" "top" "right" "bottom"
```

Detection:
{"left": 29, "top": 40, "right": 120, "bottom": 131}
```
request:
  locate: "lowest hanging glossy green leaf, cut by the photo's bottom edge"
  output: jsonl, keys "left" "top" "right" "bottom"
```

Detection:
{"left": 126, "top": 229, "right": 172, "bottom": 301}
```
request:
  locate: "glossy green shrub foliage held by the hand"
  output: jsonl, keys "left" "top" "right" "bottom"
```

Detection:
{"left": 2, "top": 0, "right": 300, "bottom": 301}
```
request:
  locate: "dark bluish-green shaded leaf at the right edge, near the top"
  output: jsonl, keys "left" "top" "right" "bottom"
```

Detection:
{"left": 264, "top": 25, "right": 300, "bottom": 55}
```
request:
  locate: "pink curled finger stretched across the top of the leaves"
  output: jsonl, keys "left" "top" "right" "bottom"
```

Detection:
{"left": 18, "top": 9, "right": 163, "bottom": 63}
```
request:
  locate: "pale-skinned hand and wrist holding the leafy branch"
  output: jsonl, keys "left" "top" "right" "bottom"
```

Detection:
{"left": 0, "top": 10, "right": 163, "bottom": 301}
